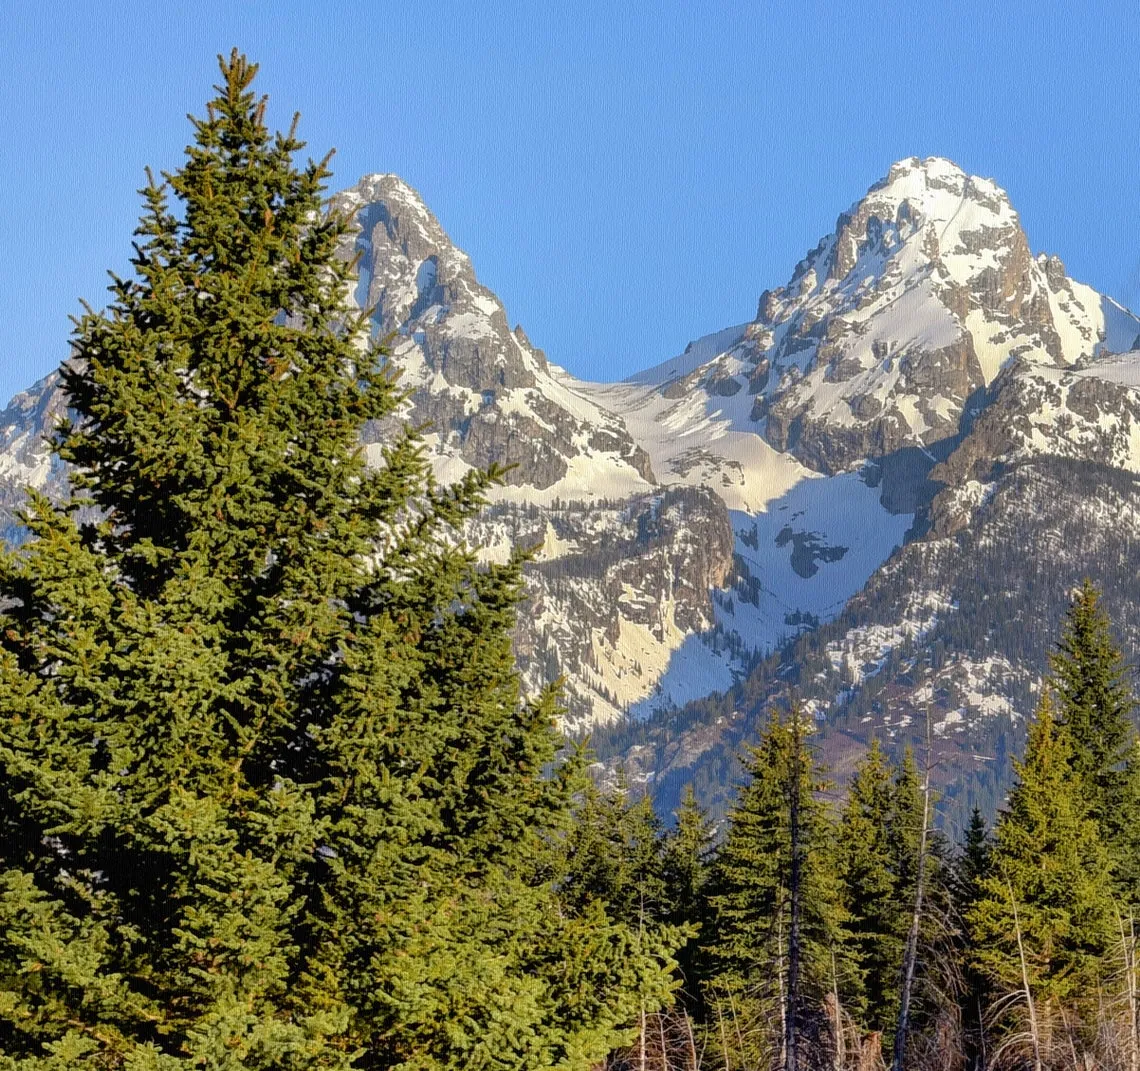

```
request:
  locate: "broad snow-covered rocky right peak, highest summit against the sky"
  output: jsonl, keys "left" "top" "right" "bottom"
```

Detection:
{"left": 642, "top": 159, "right": 1140, "bottom": 473}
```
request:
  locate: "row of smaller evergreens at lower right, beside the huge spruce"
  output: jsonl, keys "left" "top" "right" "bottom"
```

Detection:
{"left": 576, "top": 583, "right": 1140, "bottom": 1071}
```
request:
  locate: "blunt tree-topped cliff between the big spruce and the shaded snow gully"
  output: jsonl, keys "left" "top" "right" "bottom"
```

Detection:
{"left": 471, "top": 488, "right": 742, "bottom": 731}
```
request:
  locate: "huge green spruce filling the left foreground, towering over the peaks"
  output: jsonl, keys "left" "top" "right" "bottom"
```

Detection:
{"left": 0, "top": 52, "right": 670, "bottom": 1071}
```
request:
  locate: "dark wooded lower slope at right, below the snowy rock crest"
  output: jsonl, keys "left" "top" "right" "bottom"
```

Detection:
{"left": 620, "top": 455, "right": 1140, "bottom": 830}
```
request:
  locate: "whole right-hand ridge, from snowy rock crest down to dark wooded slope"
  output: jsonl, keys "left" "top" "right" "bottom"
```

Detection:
{"left": 609, "top": 351, "right": 1140, "bottom": 823}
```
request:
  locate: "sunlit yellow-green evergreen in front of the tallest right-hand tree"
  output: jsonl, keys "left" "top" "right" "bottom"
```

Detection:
{"left": 968, "top": 692, "right": 1115, "bottom": 1052}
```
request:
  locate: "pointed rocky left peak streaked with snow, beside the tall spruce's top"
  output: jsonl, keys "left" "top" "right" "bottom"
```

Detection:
{"left": 333, "top": 175, "right": 656, "bottom": 494}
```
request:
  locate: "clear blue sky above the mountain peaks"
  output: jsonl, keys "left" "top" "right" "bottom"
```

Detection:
{"left": 0, "top": 0, "right": 1140, "bottom": 399}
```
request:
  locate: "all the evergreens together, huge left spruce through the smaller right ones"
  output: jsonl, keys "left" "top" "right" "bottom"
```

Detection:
{"left": 0, "top": 51, "right": 1140, "bottom": 1071}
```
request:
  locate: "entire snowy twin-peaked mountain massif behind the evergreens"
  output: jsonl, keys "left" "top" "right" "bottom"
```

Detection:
{"left": 0, "top": 159, "right": 1140, "bottom": 816}
